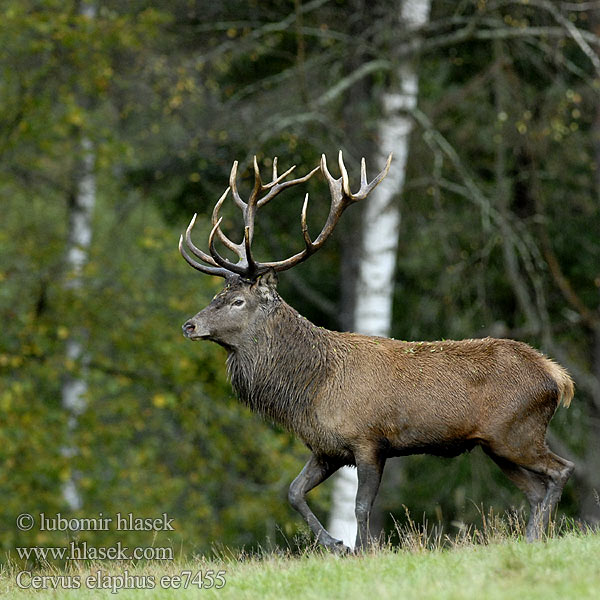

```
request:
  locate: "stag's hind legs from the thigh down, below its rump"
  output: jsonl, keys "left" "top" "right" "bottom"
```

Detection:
{"left": 484, "top": 445, "right": 574, "bottom": 542}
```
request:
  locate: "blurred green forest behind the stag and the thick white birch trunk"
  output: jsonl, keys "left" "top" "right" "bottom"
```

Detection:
{"left": 0, "top": 0, "right": 600, "bottom": 559}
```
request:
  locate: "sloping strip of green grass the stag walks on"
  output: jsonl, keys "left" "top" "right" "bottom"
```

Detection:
{"left": 0, "top": 519, "right": 600, "bottom": 600}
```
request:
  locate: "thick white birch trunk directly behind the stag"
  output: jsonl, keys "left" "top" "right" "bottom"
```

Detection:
{"left": 329, "top": 0, "right": 431, "bottom": 548}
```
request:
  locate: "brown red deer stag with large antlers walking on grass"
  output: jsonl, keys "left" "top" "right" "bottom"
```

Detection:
{"left": 179, "top": 152, "right": 573, "bottom": 551}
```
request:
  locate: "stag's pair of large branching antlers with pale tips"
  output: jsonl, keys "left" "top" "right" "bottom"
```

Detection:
{"left": 179, "top": 150, "right": 392, "bottom": 279}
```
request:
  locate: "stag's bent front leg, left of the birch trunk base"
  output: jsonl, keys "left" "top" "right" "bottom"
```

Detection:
{"left": 288, "top": 454, "right": 349, "bottom": 552}
